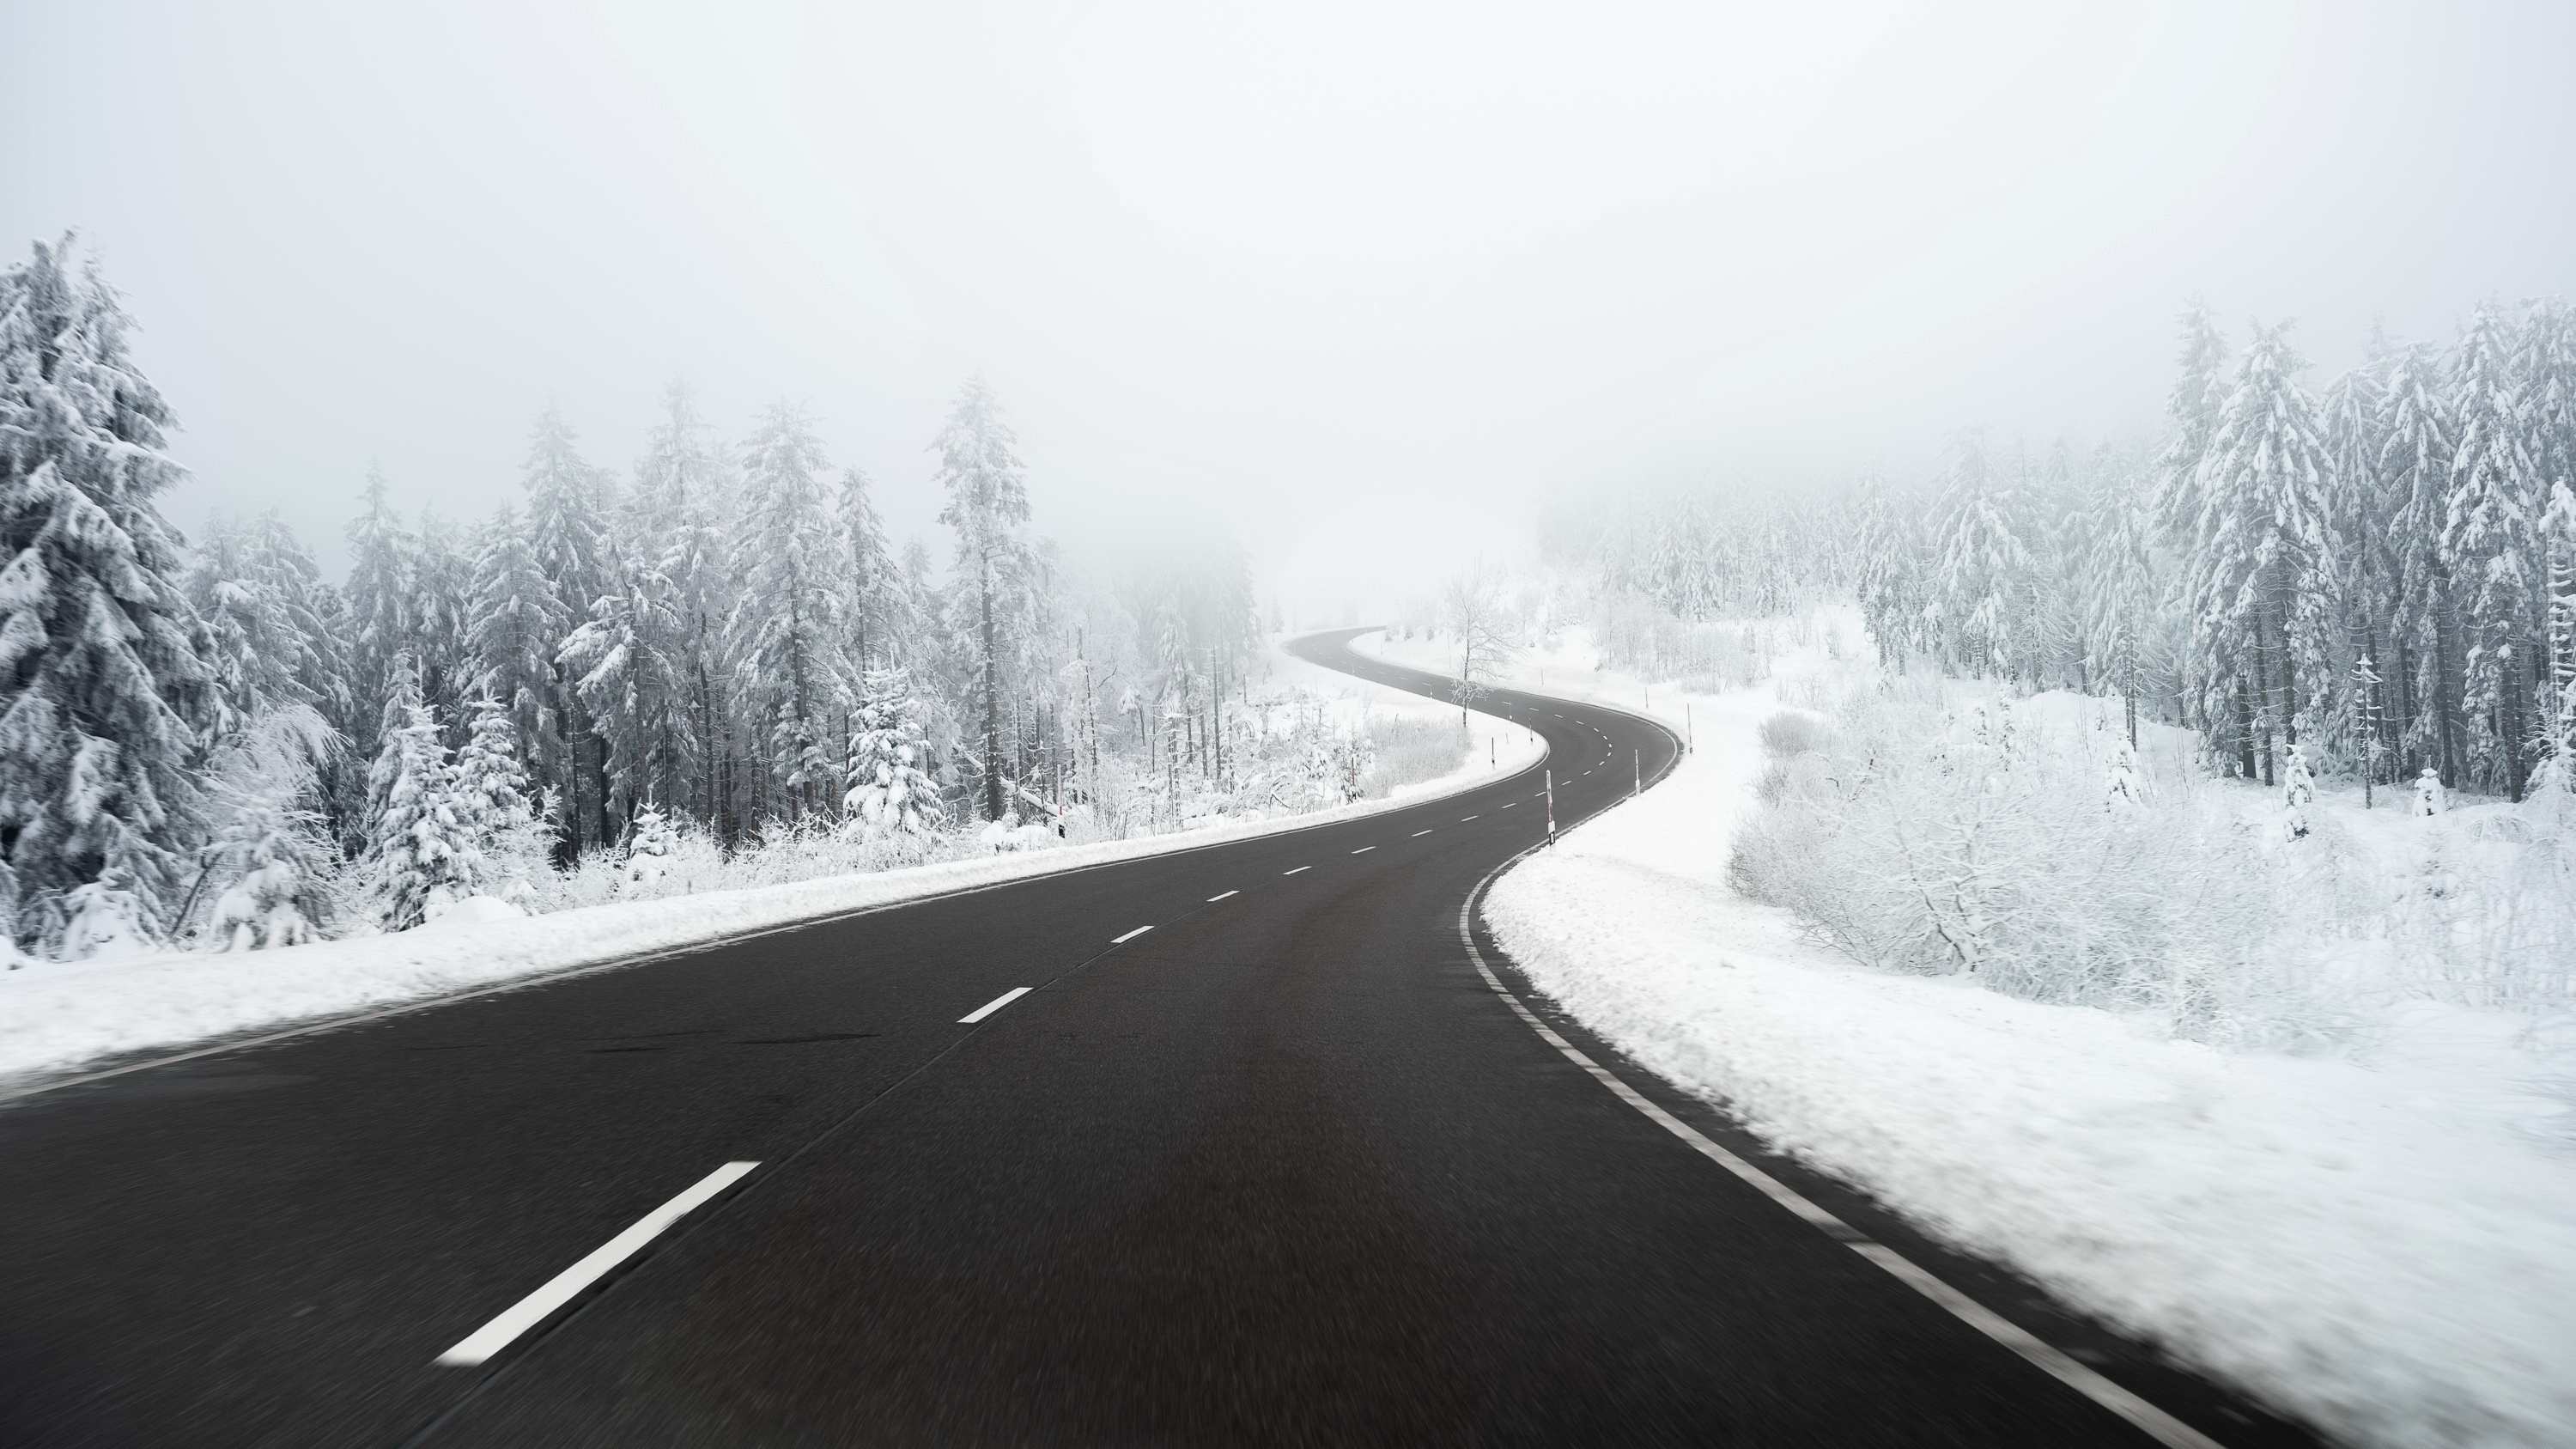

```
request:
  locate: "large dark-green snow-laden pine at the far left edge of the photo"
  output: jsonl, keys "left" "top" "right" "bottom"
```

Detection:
{"left": 0, "top": 237, "right": 216, "bottom": 952}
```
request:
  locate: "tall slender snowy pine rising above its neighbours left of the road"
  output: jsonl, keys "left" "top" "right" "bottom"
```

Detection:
{"left": 930, "top": 374, "right": 1030, "bottom": 820}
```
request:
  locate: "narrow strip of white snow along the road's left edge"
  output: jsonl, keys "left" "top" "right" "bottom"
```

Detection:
{"left": 0, "top": 631, "right": 1543, "bottom": 1088}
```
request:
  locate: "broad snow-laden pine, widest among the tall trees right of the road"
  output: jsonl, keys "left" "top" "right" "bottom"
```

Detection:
{"left": 2187, "top": 322, "right": 2339, "bottom": 784}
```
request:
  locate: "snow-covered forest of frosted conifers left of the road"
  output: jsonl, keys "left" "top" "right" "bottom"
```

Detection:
{"left": 0, "top": 240, "right": 1463, "bottom": 959}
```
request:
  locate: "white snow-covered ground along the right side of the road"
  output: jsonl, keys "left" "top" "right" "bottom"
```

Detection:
{"left": 1368, "top": 616, "right": 2576, "bottom": 1446}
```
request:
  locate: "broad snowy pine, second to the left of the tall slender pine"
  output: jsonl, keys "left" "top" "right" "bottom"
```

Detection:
{"left": 732, "top": 402, "right": 850, "bottom": 818}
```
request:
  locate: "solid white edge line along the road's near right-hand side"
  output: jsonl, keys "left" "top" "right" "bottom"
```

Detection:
{"left": 1458, "top": 851, "right": 2223, "bottom": 1449}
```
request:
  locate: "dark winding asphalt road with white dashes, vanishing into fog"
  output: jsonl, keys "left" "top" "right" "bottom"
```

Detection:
{"left": 0, "top": 631, "right": 2311, "bottom": 1449}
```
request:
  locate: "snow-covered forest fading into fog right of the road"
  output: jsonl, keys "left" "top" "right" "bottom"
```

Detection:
{"left": 1600, "top": 299, "right": 2576, "bottom": 800}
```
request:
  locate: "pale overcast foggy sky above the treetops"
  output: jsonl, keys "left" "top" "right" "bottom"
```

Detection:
{"left": 0, "top": 0, "right": 2576, "bottom": 603}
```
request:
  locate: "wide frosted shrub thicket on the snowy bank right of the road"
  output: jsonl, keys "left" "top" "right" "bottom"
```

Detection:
{"left": 1728, "top": 696, "right": 2331, "bottom": 1044}
